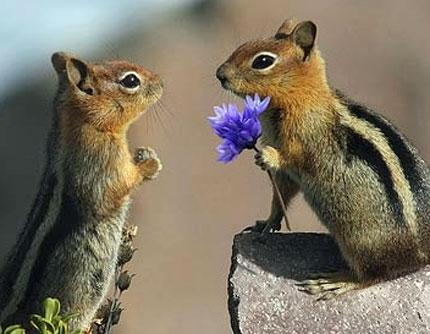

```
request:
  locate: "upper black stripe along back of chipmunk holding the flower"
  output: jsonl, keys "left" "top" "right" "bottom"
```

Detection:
{"left": 340, "top": 96, "right": 423, "bottom": 201}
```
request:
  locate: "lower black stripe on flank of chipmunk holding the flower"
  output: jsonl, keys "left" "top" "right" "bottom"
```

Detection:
{"left": 344, "top": 127, "right": 407, "bottom": 226}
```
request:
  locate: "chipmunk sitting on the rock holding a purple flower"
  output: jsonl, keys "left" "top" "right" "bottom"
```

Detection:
{"left": 216, "top": 19, "right": 430, "bottom": 299}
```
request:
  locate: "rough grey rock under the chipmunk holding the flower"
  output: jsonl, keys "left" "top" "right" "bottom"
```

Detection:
{"left": 228, "top": 233, "right": 430, "bottom": 334}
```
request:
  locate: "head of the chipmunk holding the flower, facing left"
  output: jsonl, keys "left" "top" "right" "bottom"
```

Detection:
{"left": 216, "top": 19, "right": 325, "bottom": 103}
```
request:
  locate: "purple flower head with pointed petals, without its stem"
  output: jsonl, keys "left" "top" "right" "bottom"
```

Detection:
{"left": 208, "top": 94, "right": 270, "bottom": 163}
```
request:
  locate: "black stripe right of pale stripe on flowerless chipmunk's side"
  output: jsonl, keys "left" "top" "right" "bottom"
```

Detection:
{"left": 20, "top": 188, "right": 84, "bottom": 307}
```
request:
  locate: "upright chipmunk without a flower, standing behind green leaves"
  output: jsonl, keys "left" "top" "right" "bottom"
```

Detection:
{"left": 0, "top": 52, "right": 163, "bottom": 329}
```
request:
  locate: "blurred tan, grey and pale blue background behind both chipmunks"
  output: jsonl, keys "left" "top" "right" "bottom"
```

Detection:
{"left": 0, "top": 0, "right": 430, "bottom": 334}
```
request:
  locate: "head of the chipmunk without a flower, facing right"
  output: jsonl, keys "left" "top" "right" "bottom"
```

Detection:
{"left": 52, "top": 52, "right": 163, "bottom": 131}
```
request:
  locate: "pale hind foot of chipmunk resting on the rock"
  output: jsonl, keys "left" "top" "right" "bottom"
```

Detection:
{"left": 296, "top": 271, "right": 362, "bottom": 300}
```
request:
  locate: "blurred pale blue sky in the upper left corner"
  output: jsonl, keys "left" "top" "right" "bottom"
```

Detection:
{"left": 0, "top": 0, "right": 194, "bottom": 98}
